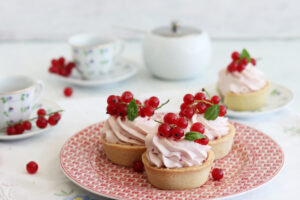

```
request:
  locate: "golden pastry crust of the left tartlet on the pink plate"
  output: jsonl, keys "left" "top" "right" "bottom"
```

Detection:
{"left": 101, "top": 136, "right": 146, "bottom": 167}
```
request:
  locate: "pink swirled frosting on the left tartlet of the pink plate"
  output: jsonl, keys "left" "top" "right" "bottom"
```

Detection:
{"left": 102, "top": 116, "right": 158, "bottom": 145}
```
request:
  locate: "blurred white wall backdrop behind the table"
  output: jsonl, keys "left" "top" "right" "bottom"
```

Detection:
{"left": 0, "top": 0, "right": 300, "bottom": 40}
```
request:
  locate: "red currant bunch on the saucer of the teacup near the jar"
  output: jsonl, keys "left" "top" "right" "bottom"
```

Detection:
{"left": 49, "top": 57, "right": 75, "bottom": 77}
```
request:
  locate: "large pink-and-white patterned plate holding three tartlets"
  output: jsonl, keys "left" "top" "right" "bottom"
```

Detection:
{"left": 60, "top": 122, "right": 284, "bottom": 200}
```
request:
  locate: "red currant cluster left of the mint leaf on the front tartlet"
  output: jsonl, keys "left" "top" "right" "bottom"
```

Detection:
{"left": 158, "top": 113, "right": 188, "bottom": 140}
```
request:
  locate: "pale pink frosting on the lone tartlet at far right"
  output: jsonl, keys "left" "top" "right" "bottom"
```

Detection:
{"left": 218, "top": 64, "right": 267, "bottom": 96}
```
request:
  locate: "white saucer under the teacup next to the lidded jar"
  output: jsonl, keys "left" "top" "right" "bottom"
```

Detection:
{"left": 53, "top": 58, "right": 138, "bottom": 87}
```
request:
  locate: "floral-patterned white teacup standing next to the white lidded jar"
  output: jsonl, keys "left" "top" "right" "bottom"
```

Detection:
{"left": 69, "top": 33, "right": 122, "bottom": 80}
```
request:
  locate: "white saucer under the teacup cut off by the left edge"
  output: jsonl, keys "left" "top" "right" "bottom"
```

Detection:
{"left": 0, "top": 98, "right": 61, "bottom": 140}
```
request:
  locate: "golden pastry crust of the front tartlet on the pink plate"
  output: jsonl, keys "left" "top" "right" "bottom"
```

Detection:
{"left": 142, "top": 151, "right": 215, "bottom": 190}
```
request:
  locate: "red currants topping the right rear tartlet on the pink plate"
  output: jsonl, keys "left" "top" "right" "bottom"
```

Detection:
{"left": 179, "top": 90, "right": 226, "bottom": 119}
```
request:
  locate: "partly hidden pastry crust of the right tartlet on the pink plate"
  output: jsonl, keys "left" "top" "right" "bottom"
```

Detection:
{"left": 208, "top": 124, "right": 235, "bottom": 159}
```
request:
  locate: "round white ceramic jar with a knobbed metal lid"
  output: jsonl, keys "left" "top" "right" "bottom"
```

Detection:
{"left": 143, "top": 23, "right": 211, "bottom": 80}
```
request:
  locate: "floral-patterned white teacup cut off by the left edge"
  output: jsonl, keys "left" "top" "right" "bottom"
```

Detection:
{"left": 0, "top": 75, "right": 44, "bottom": 129}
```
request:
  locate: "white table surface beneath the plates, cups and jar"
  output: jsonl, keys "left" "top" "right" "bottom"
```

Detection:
{"left": 0, "top": 40, "right": 300, "bottom": 200}
